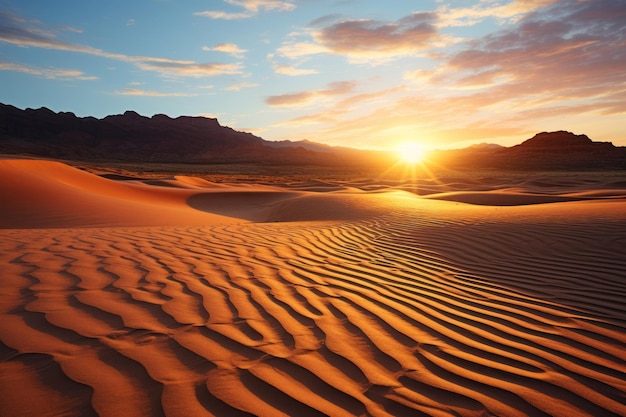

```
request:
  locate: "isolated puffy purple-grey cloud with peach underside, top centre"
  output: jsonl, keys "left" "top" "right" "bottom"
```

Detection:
{"left": 278, "top": 12, "right": 440, "bottom": 61}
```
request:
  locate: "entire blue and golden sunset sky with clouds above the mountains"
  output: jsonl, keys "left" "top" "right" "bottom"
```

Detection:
{"left": 0, "top": 0, "right": 626, "bottom": 149}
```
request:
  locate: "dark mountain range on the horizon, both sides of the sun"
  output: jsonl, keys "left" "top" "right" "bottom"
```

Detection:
{"left": 0, "top": 103, "right": 626, "bottom": 170}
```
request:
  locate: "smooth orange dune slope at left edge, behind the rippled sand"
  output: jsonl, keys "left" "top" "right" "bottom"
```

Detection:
{"left": 0, "top": 160, "right": 241, "bottom": 228}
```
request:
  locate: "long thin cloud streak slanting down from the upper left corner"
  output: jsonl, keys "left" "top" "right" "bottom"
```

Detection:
{"left": 0, "top": 11, "right": 241, "bottom": 78}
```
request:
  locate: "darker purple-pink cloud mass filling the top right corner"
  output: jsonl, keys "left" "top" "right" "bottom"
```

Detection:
{"left": 432, "top": 0, "right": 626, "bottom": 102}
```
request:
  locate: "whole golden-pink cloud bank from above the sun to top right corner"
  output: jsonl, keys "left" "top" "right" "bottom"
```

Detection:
{"left": 275, "top": 0, "right": 626, "bottom": 148}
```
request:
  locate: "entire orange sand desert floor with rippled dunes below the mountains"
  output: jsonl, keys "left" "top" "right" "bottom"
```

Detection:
{"left": 0, "top": 160, "right": 626, "bottom": 417}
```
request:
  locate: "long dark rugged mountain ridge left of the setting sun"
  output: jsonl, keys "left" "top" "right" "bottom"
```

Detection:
{"left": 0, "top": 104, "right": 370, "bottom": 165}
